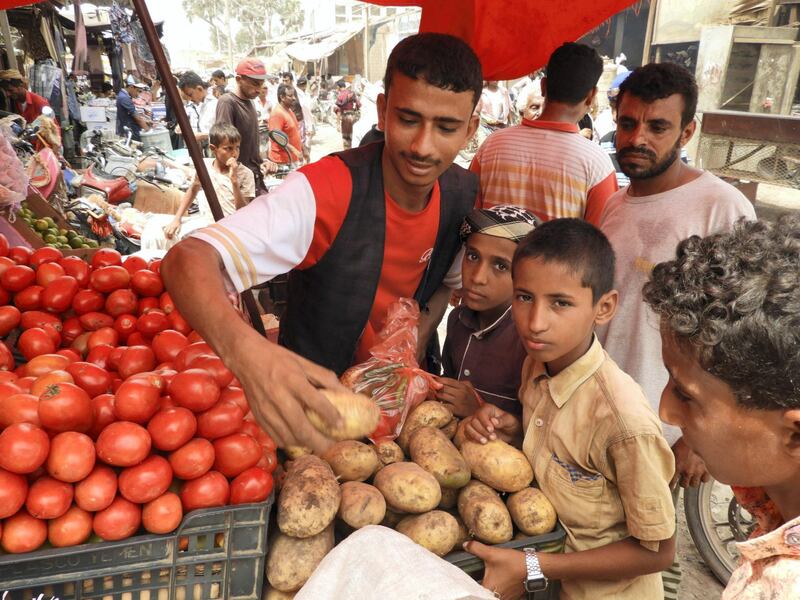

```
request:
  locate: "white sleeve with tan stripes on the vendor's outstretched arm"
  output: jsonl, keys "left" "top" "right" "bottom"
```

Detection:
{"left": 192, "top": 172, "right": 316, "bottom": 292}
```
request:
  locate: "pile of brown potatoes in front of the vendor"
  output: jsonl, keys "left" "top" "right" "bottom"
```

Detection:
{"left": 266, "top": 401, "right": 556, "bottom": 599}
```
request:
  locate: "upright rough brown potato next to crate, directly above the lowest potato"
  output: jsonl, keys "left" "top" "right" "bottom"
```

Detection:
{"left": 278, "top": 454, "right": 341, "bottom": 538}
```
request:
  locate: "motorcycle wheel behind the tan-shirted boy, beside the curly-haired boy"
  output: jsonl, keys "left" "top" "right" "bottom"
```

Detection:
{"left": 683, "top": 479, "right": 755, "bottom": 585}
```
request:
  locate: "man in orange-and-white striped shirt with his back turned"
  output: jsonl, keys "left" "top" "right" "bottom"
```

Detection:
{"left": 470, "top": 43, "right": 617, "bottom": 225}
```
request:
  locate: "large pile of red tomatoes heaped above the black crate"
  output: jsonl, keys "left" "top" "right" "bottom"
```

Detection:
{"left": 0, "top": 235, "right": 276, "bottom": 553}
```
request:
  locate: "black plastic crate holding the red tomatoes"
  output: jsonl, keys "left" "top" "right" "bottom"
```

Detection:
{"left": 0, "top": 496, "right": 274, "bottom": 600}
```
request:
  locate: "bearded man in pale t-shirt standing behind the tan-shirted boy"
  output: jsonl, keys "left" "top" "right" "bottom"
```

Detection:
{"left": 597, "top": 63, "right": 755, "bottom": 599}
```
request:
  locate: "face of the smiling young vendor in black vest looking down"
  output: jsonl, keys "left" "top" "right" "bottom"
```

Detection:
{"left": 378, "top": 73, "right": 478, "bottom": 191}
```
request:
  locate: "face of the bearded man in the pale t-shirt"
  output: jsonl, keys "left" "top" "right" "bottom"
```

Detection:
{"left": 616, "top": 93, "right": 695, "bottom": 179}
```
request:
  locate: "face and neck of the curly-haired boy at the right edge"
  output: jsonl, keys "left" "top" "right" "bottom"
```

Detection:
{"left": 659, "top": 327, "right": 800, "bottom": 487}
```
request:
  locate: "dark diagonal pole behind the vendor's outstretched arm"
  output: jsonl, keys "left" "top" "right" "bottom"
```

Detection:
{"left": 133, "top": 0, "right": 266, "bottom": 335}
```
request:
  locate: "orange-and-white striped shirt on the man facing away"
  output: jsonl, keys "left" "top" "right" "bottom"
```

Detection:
{"left": 470, "top": 119, "right": 617, "bottom": 225}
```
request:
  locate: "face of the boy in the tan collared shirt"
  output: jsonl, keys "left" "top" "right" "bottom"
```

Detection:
{"left": 511, "top": 257, "right": 616, "bottom": 375}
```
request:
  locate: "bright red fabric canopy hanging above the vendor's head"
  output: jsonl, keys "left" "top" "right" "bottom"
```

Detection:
{"left": 366, "top": 0, "right": 634, "bottom": 80}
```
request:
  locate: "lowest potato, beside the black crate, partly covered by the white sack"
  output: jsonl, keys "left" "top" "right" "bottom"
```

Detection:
{"left": 267, "top": 525, "right": 334, "bottom": 592}
